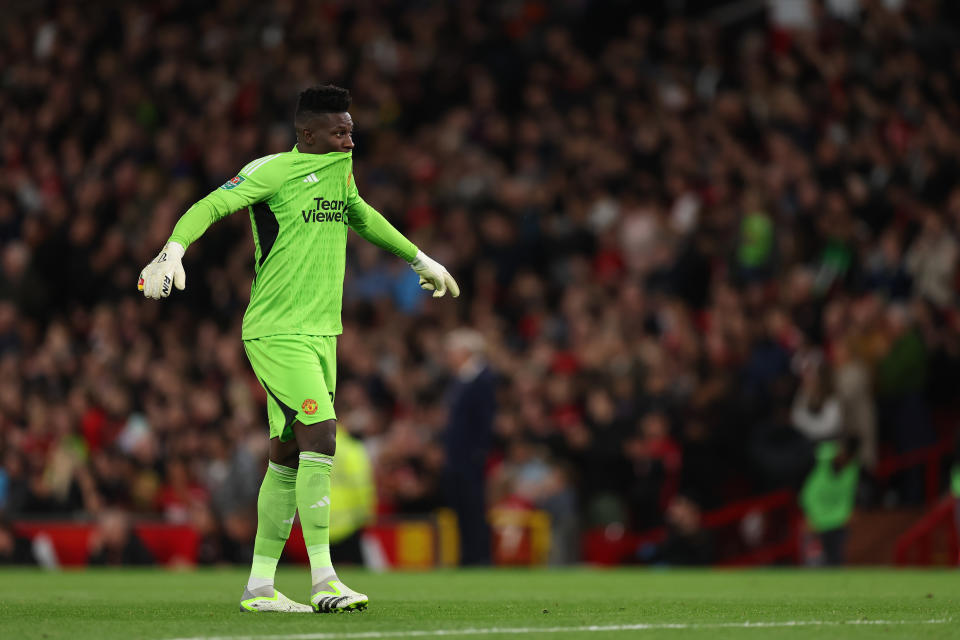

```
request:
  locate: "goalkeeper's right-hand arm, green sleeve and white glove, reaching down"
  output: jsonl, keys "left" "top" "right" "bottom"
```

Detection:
{"left": 347, "top": 175, "right": 460, "bottom": 298}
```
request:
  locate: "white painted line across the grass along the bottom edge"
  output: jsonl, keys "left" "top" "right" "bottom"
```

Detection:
{"left": 167, "top": 618, "right": 953, "bottom": 640}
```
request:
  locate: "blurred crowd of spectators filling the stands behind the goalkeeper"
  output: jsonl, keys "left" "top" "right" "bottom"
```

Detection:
{"left": 0, "top": 0, "right": 960, "bottom": 561}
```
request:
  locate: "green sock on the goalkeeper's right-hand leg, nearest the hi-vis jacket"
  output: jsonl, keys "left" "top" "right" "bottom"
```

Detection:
{"left": 297, "top": 451, "right": 337, "bottom": 592}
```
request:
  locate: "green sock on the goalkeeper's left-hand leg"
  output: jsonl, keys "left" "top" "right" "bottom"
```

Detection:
{"left": 247, "top": 462, "right": 297, "bottom": 597}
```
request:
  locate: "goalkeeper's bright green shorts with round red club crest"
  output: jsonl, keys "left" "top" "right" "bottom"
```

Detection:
{"left": 243, "top": 335, "right": 337, "bottom": 442}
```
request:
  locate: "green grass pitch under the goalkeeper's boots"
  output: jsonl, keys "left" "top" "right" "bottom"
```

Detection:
{"left": 0, "top": 568, "right": 960, "bottom": 640}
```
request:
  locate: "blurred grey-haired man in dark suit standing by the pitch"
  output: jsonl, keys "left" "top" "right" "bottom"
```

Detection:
{"left": 443, "top": 329, "right": 496, "bottom": 565}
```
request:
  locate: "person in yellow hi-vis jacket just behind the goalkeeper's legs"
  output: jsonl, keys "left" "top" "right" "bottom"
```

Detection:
{"left": 330, "top": 423, "right": 376, "bottom": 564}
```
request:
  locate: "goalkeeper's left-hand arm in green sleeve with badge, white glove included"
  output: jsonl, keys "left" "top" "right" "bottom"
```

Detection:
{"left": 137, "top": 155, "right": 279, "bottom": 299}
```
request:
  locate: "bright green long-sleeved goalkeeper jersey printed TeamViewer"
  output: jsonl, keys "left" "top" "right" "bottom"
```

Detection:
{"left": 170, "top": 147, "right": 417, "bottom": 340}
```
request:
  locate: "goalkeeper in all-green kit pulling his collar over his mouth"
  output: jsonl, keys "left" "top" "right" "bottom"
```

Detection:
{"left": 139, "top": 85, "right": 460, "bottom": 613}
